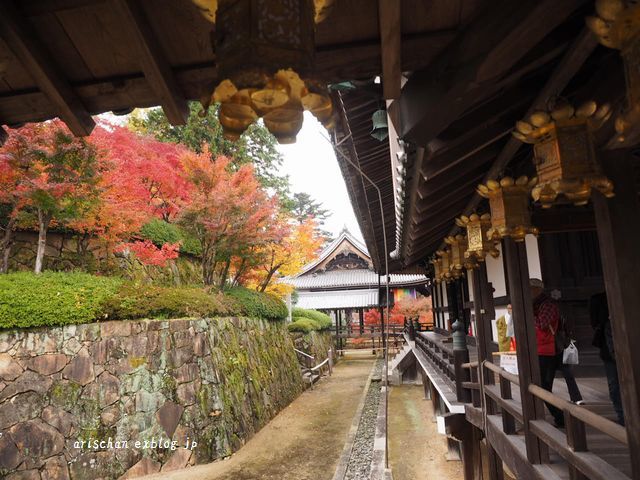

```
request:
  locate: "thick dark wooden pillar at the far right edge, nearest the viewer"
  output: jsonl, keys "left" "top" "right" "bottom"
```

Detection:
{"left": 593, "top": 150, "right": 640, "bottom": 479}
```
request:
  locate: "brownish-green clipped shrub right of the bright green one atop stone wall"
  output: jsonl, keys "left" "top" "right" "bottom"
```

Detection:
{"left": 102, "top": 283, "right": 241, "bottom": 320}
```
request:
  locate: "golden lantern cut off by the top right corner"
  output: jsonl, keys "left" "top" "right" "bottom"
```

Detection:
{"left": 586, "top": 0, "right": 640, "bottom": 141}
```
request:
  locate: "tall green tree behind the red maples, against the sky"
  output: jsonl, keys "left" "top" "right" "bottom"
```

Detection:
{"left": 129, "top": 102, "right": 290, "bottom": 202}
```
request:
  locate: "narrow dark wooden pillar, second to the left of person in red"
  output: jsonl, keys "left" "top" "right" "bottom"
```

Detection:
{"left": 473, "top": 262, "right": 504, "bottom": 480}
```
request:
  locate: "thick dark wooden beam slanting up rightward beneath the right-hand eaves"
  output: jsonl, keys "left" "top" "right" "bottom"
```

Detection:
{"left": 392, "top": 0, "right": 584, "bottom": 145}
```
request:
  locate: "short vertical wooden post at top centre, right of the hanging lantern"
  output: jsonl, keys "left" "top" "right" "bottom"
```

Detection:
{"left": 378, "top": 0, "right": 402, "bottom": 100}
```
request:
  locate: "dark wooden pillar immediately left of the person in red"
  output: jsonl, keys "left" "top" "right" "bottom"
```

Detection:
{"left": 502, "top": 238, "right": 549, "bottom": 464}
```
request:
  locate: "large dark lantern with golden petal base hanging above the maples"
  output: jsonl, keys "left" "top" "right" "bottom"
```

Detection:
{"left": 199, "top": 0, "right": 334, "bottom": 143}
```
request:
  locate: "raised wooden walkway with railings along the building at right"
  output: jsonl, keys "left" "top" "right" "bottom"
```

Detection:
{"left": 410, "top": 332, "right": 632, "bottom": 480}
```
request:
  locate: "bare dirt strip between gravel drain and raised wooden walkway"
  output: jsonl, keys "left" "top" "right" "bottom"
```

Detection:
{"left": 389, "top": 385, "right": 463, "bottom": 480}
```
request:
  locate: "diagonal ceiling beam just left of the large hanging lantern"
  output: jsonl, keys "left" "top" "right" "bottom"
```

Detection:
{"left": 114, "top": 0, "right": 189, "bottom": 125}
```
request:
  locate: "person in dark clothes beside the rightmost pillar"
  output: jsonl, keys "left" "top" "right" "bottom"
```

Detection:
{"left": 589, "top": 292, "right": 624, "bottom": 425}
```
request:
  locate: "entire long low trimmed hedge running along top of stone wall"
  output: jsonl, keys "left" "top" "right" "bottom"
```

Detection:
{"left": 0, "top": 272, "right": 287, "bottom": 329}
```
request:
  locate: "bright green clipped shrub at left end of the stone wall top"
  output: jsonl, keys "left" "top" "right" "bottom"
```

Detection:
{"left": 0, "top": 272, "right": 122, "bottom": 329}
